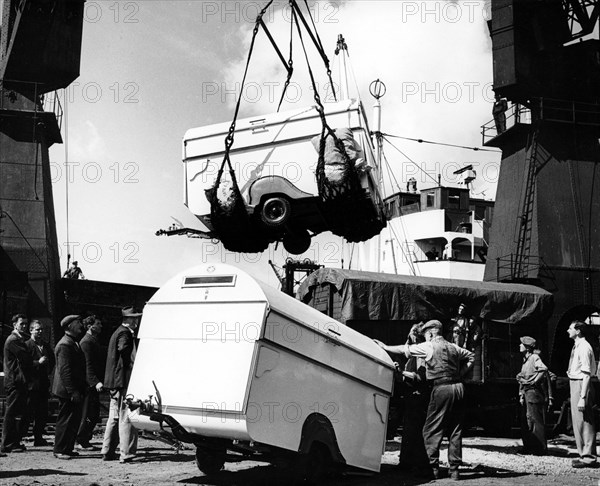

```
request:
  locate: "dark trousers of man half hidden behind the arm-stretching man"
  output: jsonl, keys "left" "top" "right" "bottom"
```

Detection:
{"left": 399, "top": 388, "right": 429, "bottom": 469}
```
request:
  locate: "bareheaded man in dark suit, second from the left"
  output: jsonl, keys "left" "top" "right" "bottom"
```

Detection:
{"left": 24, "top": 320, "right": 54, "bottom": 447}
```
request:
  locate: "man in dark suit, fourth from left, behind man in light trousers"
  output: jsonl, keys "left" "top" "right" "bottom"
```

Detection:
{"left": 77, "top": 315, "right": 104, "bottom": 451}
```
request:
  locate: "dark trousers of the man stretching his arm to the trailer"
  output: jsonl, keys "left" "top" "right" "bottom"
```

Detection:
{"left": 423, "top": 383, "right": 465, "bottom": 470}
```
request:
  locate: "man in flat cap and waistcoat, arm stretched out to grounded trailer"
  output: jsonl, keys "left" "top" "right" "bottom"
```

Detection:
{"left": 376, "top": 320, "right": 475, "bottom": 480}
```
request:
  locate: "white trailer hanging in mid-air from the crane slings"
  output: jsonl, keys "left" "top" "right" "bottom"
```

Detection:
{"left": 183, "top": 100, "right": 386, "bottom": 254}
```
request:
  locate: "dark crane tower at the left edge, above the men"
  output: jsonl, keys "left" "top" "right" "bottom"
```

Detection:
{"left": 0, "top": 0, "right": 84, "bottom": 342}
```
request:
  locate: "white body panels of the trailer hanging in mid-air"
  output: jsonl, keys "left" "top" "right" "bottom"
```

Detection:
{"left": 183, "top": 100, "right": 380, "bottom": 216}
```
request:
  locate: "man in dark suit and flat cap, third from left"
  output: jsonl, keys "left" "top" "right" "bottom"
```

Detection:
{"left": 52, "top": 315, "right": 86, "bottom": 459}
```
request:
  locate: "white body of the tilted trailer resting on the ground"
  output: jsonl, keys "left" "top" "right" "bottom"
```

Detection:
{"left": 128, "top": 264, "right": 394, "bottom": 471}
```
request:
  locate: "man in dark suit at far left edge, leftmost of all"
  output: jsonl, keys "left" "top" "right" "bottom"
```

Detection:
{"left": 1, "top": 314, "right": 33, "bottom": 452}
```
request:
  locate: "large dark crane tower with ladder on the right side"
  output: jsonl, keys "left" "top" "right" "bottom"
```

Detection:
{"left": 483, "top": 0, "right": 600, "bottom": 370}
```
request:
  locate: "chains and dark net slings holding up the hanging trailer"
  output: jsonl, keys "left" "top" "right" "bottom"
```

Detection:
{"left": 206, "top": 0, "right": 385, "bottom": 253}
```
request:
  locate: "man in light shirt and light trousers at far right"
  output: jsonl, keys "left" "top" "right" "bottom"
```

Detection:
{"left": 567, "top": 321, "right": 598, "bottom": 468}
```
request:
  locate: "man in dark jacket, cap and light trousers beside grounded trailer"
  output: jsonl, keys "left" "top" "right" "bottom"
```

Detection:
{"left": 102, "top": 307, "right": 142, "bottom": 463}
